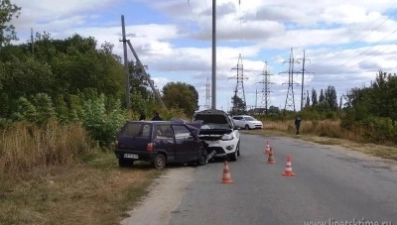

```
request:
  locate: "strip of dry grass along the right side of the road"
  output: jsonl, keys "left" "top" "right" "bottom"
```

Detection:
{"left": 254, "top": 120, "right": 397, "bottom": 160}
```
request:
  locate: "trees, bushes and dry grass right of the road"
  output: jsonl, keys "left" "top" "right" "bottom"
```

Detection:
{"left": 241, "top": 71, "right": 397, "bottom": 160}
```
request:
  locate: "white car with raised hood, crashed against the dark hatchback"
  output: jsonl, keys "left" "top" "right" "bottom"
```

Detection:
{"left": 193, "top": 109, "right": 240, "bottom": 161}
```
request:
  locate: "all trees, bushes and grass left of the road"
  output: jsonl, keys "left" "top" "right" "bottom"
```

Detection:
{"left": 0, "top": 0, "right": 198, "bottom": 225}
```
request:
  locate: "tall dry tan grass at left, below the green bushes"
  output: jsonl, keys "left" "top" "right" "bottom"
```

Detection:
{"left": 0, "top": 121, "right": 95, "bottom": 178}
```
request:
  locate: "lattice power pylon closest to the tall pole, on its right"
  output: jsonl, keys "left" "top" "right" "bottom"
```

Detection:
{"left": 227, "top": 53, "right": 247, "bottom": 113}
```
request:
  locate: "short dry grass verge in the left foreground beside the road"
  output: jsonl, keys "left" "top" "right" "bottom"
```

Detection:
{"left": 0, "top": 153, "right": 160, "bottom": 225}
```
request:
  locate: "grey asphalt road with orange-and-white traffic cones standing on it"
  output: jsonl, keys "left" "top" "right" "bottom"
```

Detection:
{"left": 166, "top": 135, "right": 397, "bottom": 225}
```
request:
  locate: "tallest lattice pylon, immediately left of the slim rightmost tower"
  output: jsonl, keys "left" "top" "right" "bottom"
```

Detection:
{"left": 280, "top": 48, "right": 300, "bottom": 113}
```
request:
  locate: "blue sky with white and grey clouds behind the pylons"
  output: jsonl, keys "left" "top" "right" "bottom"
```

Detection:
{"left": 13, "top": 0, "right": 397, "bottom": 110}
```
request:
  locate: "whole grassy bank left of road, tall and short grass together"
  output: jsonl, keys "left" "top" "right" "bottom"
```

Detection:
{"left": 0, "top": 123, "right": 160, "bottom": 225}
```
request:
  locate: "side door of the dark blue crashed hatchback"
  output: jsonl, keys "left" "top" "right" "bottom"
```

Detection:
{"left": 172, "top": 124, "right": 199, "bottom": 162}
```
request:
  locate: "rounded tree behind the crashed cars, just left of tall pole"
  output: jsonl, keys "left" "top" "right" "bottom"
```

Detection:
{"left": 163, "top": 82, "right": 198, "bottom": 116}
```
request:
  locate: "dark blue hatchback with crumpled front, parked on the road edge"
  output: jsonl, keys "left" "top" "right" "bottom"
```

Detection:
{"left": 115, "top": 119, "right": 208, "bottom": 169}
